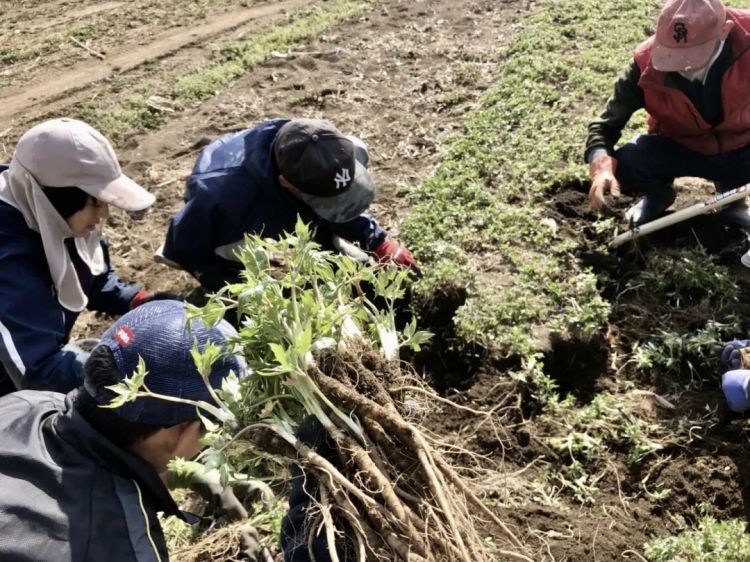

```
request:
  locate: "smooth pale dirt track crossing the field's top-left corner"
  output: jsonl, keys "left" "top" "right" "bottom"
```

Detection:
{"left": 0, "top": 0, "right": 310, "bottom": 124}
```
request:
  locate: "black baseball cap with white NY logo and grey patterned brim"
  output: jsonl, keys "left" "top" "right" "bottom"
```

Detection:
{"left": 274, "top": 119, "right": 375, "bottom": 223}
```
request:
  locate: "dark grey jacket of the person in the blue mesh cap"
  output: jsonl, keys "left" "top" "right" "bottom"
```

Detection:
{"left": 0, "top": 391, "right": 184, "bottom": 562}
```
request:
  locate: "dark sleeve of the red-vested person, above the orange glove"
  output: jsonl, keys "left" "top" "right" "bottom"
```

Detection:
{"left": 583, "top": 61, "right": 645, "bottom": 163}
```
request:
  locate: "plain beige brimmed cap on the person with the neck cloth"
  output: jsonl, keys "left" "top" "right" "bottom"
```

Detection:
{"left": 13, "top": 118, "right": 155, "bottom": 211}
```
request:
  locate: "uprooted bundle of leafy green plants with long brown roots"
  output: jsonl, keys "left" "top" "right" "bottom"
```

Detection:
{"left": 113, "top": 223, "right": 530, "bottom": 562}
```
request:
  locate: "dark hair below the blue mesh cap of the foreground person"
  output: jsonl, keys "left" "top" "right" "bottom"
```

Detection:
{"left": 73, "top": 346, "right": 170, "bottom": 449}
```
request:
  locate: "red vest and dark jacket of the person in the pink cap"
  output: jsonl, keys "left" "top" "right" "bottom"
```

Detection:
{"left": 584, "top": 10, "right": 750, "bottom": 161}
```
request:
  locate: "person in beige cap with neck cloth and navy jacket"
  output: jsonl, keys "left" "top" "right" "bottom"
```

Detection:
{"left": 0, "top": 118, "right": 172, "bottom": 395}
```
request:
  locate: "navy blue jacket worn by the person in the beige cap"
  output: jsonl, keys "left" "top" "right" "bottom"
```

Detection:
{"left": 0, "top": 178, "right": 141, "bottom": 395}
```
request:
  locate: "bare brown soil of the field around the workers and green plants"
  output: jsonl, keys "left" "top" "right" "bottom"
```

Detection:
{"left": 0, "top": 0, "right": 750, "bottom": 562}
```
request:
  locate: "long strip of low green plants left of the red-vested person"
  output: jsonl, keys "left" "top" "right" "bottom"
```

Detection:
{"left": 403, "top": 0, "right": 668, "bottom": 355}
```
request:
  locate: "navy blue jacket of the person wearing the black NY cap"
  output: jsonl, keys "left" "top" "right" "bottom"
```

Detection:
{"left": 163, "top": 119, "right": 386, "bottom": 291}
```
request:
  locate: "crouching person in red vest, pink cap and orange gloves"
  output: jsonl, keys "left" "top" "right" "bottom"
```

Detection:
{"left": 585, "top": 0, "right": 750, "bottom": 229}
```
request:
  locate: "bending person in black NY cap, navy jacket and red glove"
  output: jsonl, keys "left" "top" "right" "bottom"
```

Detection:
{"left": 158, "top": 119, "right": 417, "bottom": 291}
